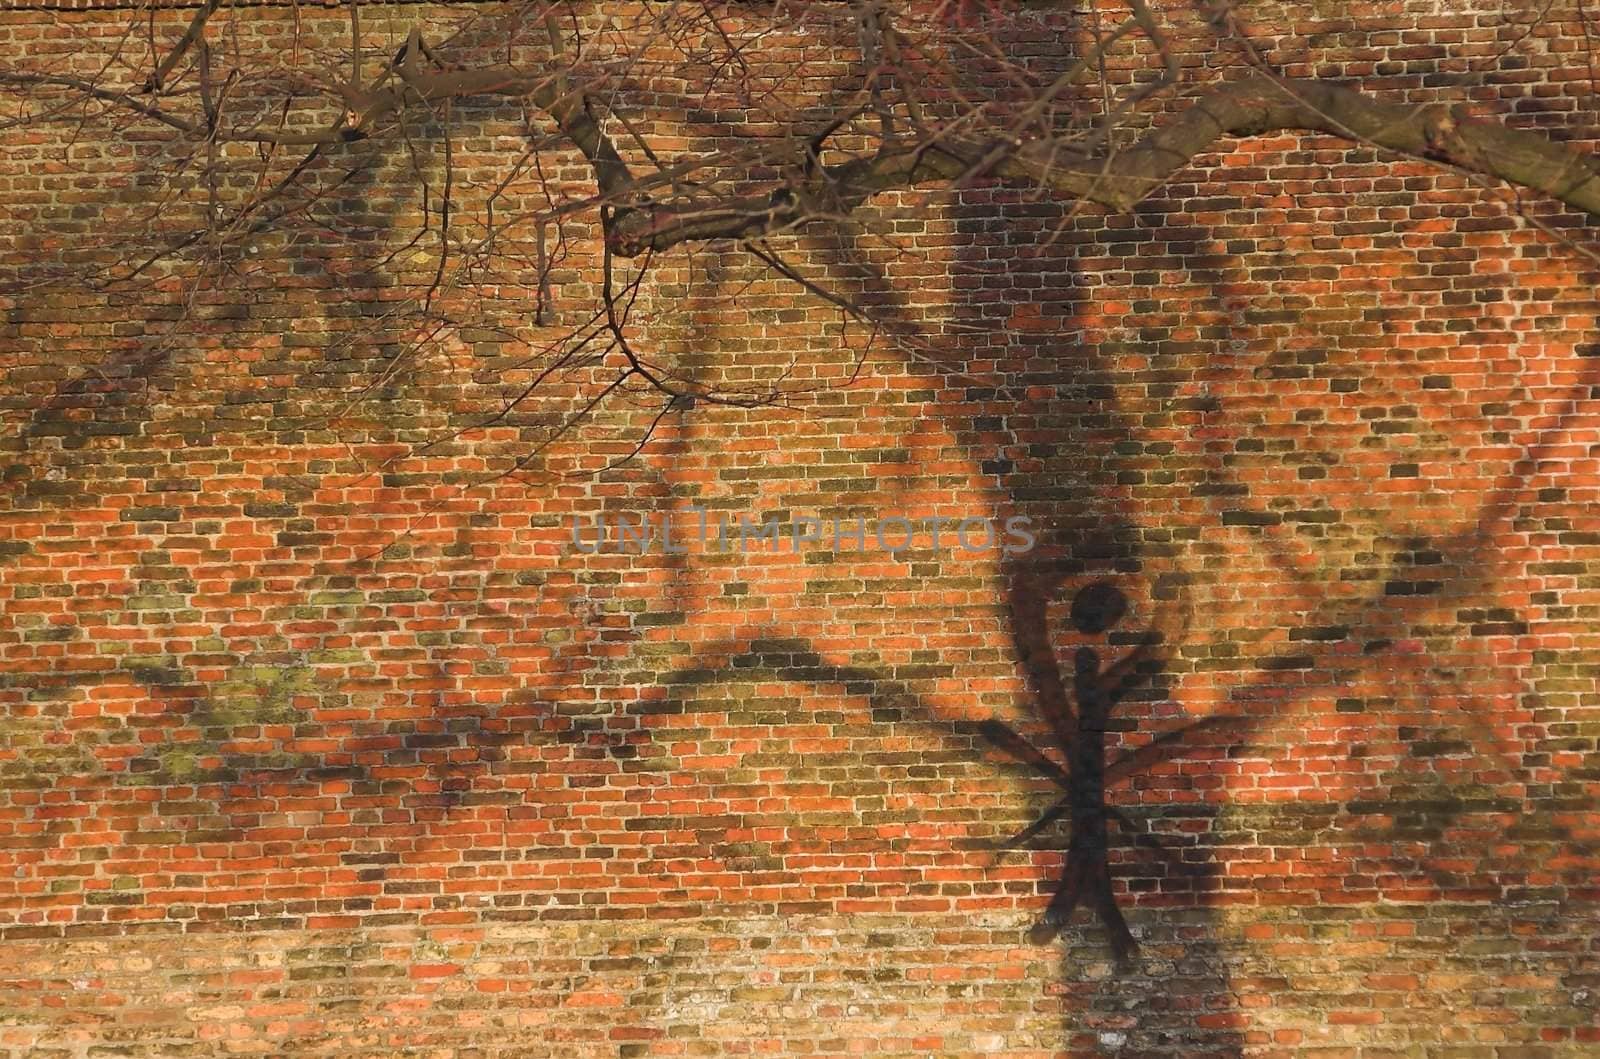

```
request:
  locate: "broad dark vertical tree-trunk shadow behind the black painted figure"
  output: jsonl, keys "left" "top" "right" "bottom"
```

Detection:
{"left": 928, "top": 187, "right": 1243, "bottom": 1059}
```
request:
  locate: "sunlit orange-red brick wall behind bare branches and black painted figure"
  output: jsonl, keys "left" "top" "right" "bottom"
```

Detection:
{"left": 0, "top": 3, "right": 1600, "bottom": 1057}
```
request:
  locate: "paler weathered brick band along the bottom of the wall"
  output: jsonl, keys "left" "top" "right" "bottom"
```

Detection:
{"left": 5, "top": 904, "right": 1594, "bottom": 1056}
